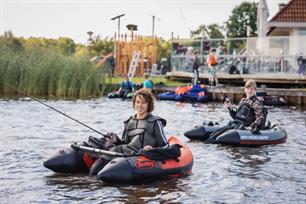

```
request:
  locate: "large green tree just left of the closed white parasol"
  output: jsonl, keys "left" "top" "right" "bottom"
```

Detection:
{"left": 225, "top": 2, "right": 258, "bottom": 38}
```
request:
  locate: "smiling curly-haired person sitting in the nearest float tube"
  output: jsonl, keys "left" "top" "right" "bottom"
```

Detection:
{"left": 90, "top": 89, "right": 169, "bottom": 175}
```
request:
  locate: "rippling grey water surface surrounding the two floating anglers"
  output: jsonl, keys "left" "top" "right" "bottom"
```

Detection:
{"left": 0, "top": 98, "right": 306, "bottom": 204}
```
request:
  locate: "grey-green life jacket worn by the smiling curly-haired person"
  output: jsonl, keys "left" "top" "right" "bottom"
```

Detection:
{"left": 114, "top": 114, "right": 167, "bottom": 153}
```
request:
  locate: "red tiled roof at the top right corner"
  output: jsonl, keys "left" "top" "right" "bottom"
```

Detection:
{"left": 270, "top": 0, "right": 306, "bottom": 22}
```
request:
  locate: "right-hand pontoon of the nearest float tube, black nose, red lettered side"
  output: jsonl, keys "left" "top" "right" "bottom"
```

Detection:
{"left": 97, "top": 136, "right": 193, "bottom": 182}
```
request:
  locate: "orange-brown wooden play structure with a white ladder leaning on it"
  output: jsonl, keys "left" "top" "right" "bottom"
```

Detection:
{"left": 114, "top": 29, "right": 157, "bottom": 78}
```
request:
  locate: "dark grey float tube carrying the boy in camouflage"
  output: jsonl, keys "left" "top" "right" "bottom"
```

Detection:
{"left": 184, "top": 122, "right": 287, "bottom": 146}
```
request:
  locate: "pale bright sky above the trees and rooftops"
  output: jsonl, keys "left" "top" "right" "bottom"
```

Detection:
{"left": 0, "top": 0, "right": 289, "bottom": 44}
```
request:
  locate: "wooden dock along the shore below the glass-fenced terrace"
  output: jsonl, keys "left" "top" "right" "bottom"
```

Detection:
{"left": 154, "top": 72, "right": 306, "bottom": 106}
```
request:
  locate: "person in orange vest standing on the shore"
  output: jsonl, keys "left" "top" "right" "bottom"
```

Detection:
{"left": 206, "top": 48, "right": 219, "bottom": 86}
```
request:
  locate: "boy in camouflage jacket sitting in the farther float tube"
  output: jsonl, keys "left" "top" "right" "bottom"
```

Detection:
{"left": 225, "top": 79, "right": 267, "bottom": 133}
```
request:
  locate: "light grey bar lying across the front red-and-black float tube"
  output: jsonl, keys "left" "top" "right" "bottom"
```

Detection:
{"left": 71, "top": 144, "right": 137, "bottom": 158}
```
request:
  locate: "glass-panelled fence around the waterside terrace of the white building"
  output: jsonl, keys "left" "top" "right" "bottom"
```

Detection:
{"left": 171, "top": 36, "right": 306, "bottom": 74}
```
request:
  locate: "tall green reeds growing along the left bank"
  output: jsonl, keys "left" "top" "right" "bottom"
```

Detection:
{"left": 0, "top": 46, "right": 110, "bottom": 98}
